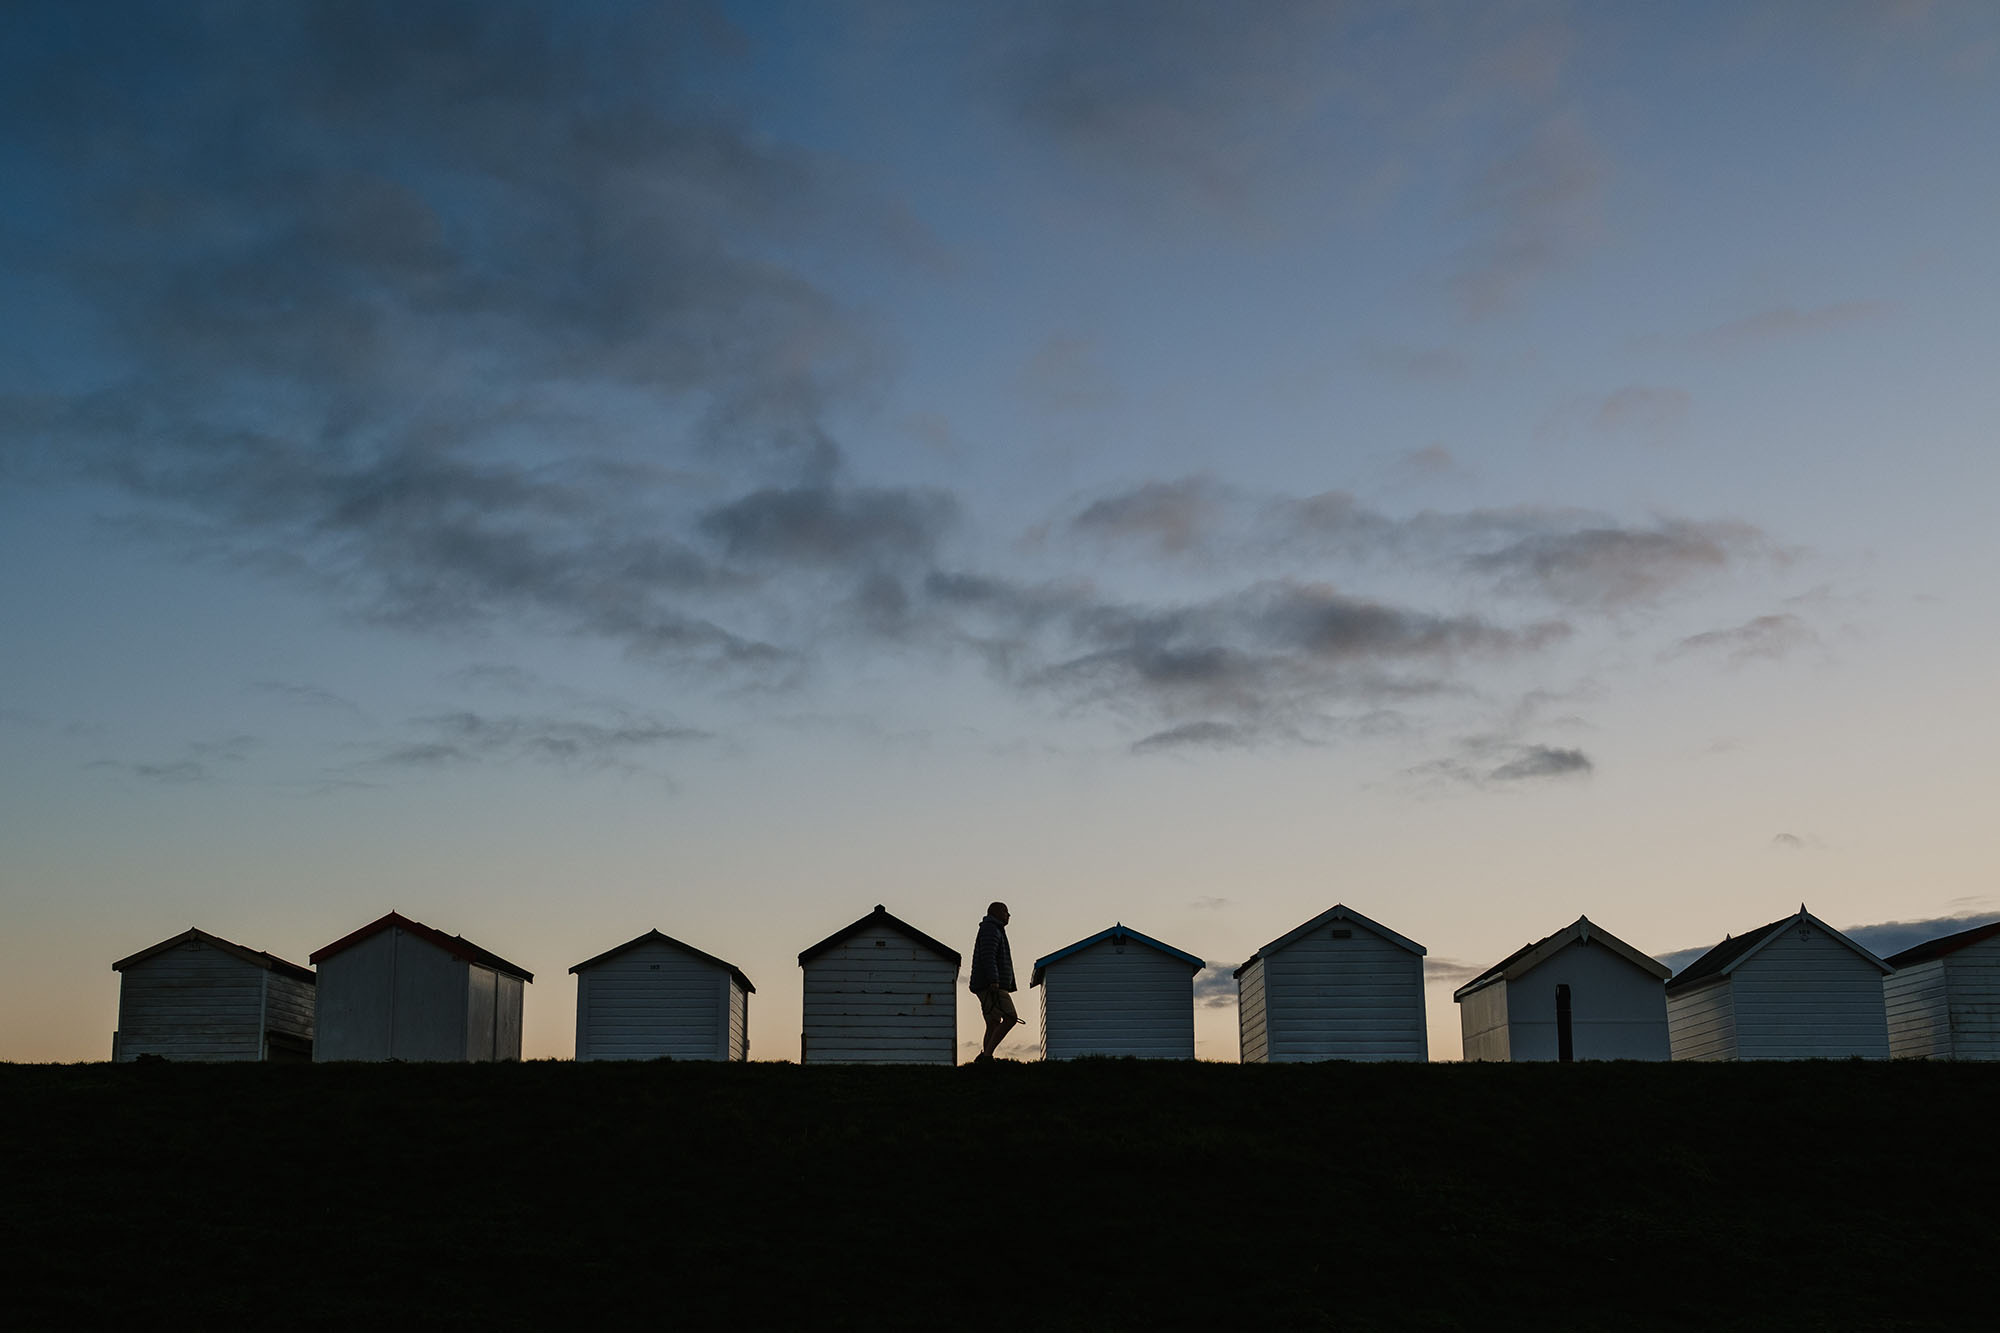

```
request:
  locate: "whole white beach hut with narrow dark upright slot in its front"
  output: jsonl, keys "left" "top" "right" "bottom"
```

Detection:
{"left": 1452, "top": 917, "right": 1670, "bottom": 1061}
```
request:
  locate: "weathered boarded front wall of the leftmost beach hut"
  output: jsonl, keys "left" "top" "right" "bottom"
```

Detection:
{"left": 114, "top": 939, "right": 266, "bottom": 1061}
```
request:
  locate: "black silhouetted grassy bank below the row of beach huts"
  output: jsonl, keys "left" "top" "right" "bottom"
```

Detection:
{"left": 0, "top": 1063, "right": 2000, "bottom": 1329}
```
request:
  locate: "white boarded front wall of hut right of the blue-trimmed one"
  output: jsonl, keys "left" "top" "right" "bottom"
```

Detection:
{"left": 1264, "top": 921, "right": 1430, "bottom": 1061}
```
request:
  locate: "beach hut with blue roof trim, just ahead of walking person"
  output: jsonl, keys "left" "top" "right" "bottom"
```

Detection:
{"left": 1028, "top": 925, "right": 1208, "bottom": 1061}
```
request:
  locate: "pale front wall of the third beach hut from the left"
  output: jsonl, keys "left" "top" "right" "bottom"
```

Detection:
{"left": 576, "top": 941, "right": 736, "bottom": 1061}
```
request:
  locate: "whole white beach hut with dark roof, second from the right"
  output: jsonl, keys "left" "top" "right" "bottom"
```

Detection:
{"left": 1666, "top": 903, "right": 1890, "bottom": 1061}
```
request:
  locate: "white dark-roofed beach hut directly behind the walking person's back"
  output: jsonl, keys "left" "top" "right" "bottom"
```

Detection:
{"left": 798, "top": 903, "right": 958, "bottom": 1065}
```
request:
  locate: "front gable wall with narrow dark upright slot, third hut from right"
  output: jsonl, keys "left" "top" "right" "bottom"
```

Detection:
{"left": 1506, "top": 941, "right": 1672, "bottom": 1061}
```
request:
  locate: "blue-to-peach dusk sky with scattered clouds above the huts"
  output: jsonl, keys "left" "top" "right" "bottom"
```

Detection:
{"left": 0, "top": 0, "right": 2000, "bottom": 1061}
